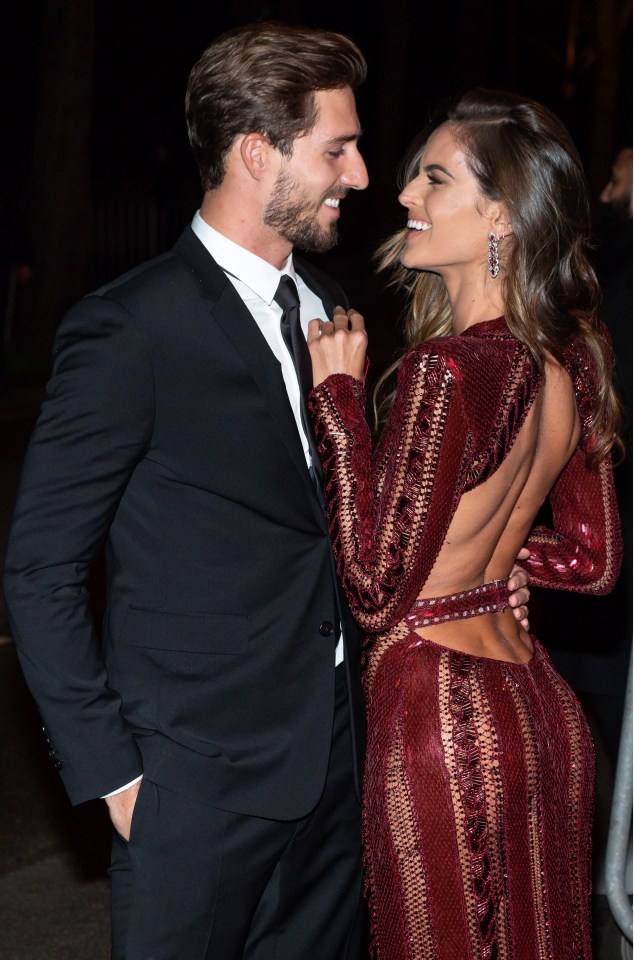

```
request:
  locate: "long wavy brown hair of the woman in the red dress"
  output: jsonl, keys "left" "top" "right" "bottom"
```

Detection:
{"left": 375, "top": 88, "right": 623, "bottom": 466}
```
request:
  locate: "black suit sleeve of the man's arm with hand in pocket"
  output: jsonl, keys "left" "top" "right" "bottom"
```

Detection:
{"left": 4, "top": 296, "right": 154, "bottom": 803}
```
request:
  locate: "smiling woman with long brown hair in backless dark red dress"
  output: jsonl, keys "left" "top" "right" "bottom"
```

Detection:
{"left": 309, "top": 90, "right": 621, "bottom": 960}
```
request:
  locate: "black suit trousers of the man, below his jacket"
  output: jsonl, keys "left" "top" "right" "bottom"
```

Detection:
{"left": 109, "top": 667, "right": 364, "bottom": 960}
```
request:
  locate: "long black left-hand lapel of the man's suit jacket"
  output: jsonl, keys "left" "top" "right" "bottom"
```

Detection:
{"left": 174, "top": 227, "right": 324, "bottom": 522}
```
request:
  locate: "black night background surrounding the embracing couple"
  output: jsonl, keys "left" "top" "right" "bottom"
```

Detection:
{"left": 0, "top": 0, "right": 632, "bottom": 960}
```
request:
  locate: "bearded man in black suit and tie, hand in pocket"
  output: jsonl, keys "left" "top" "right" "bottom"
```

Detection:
{"left": 5, "top": 23, "right": 527, "bottom": 960}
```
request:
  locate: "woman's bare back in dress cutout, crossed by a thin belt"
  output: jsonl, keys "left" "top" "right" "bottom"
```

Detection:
{"left": 419, "top": 363, "right": 580, "bottom": 662}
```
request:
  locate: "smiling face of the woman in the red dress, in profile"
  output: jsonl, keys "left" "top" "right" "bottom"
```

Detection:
{"left": 399, "top": 123, "right": 502, "bottom": 277}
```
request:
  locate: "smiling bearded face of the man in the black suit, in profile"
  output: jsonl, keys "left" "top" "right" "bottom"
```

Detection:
{"left": 264, "top": 87, "right": 368, "bottom": 253}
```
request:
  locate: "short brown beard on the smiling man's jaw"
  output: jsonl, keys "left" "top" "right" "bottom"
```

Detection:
{"left": 264, "top": 170, "right": 343, "bottom": 253}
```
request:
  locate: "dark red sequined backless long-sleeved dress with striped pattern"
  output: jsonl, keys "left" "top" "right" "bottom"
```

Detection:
{"left": 310, "top": 319, "right": 622, "bottom": 960}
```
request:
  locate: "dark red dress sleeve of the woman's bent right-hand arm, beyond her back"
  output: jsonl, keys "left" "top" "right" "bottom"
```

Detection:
{"left": 521, "top": 446, "right": 623, "bottom": 595}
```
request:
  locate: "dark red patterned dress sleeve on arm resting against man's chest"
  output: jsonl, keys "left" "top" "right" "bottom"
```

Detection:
{"left": 309, "top": 345, "right": 469, "bottom": 632}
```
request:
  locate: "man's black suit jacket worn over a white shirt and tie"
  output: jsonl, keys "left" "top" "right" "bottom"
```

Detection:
{"left": 4, "top": 228, "right": 363, "bottom": 819}
